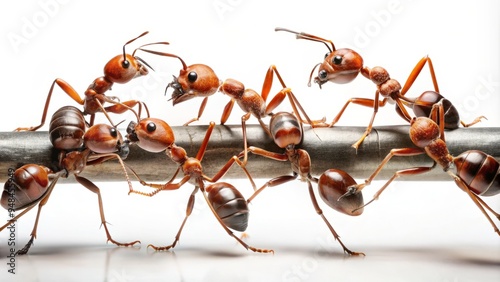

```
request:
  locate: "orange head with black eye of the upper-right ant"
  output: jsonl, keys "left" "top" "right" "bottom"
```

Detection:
{"left": 309, "top": 48, "right": 363, "bottom": 87}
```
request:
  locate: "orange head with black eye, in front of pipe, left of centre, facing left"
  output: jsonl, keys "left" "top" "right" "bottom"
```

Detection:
{"left": 127, "top": 118, "right": 175, "bottom": 153}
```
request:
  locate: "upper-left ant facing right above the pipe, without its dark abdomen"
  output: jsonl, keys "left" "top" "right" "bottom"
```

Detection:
{"left": 15, "top": 31, "right": 169, "bottom": 131}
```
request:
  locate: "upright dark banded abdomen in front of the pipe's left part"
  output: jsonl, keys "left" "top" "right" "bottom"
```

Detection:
{"left": 49, "top": 106, "right": 86, "bottom": 150}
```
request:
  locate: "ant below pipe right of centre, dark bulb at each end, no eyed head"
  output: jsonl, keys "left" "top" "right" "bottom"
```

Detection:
{"left": 240, "top": 112, "right": 364, "bottom": 256}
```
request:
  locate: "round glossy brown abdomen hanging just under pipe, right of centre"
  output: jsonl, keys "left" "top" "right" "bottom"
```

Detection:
{"left": 318, "top": 169, "right": 364, "bottom": 216}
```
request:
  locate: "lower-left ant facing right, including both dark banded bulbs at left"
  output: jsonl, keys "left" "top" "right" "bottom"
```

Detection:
{"left": 0, "top": 106, "right": 140, "bottom": 255}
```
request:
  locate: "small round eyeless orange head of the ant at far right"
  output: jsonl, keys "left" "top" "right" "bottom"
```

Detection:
{"left": 410, "top": 117, "right": 440, "bottom": 148}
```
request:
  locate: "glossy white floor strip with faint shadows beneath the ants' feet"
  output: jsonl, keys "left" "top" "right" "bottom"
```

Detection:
{"left": 0, "top": 245, "right": 500, "bottom": 281}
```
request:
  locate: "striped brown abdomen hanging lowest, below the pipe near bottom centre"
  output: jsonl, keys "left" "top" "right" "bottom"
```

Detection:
{"left": 205, "top": 182, "right": 249, "bottom": 232}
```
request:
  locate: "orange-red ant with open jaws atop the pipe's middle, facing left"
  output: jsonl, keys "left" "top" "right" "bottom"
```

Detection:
{"left": 135, "top": 48, "right": 324, "bottom": 166}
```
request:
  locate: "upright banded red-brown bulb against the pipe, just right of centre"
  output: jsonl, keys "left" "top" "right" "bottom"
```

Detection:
{"left": 269, "top": 112, "right": 302, "bottom": 148}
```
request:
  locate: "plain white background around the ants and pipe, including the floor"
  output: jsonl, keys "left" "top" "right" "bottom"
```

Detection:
{"left": 0, "top": 0, "right": 500, "bottom": 281}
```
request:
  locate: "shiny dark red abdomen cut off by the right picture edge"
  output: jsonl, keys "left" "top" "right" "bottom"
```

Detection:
{"left": 453, "top": 150, "right": 500, "bottom": 196}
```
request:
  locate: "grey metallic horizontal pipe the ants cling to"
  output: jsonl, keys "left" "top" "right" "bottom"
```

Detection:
{"left": 0, "top": 125, "right": 500, "bottom": 182}
